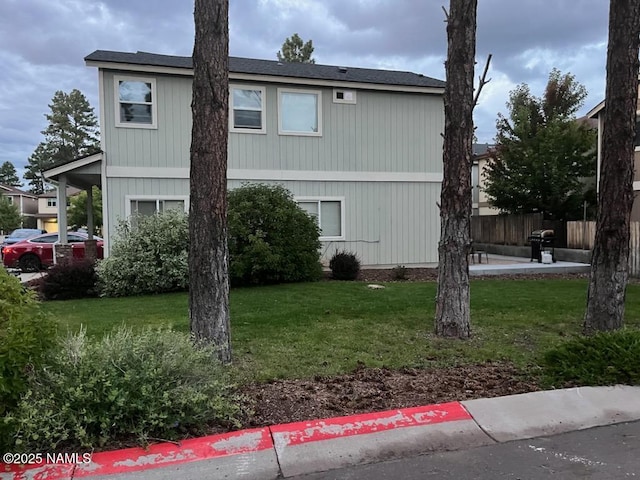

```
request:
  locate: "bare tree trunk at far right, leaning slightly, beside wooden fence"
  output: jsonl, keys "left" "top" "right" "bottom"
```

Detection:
{"left": 583, "top": 0, "right": 640, "bottom": 334}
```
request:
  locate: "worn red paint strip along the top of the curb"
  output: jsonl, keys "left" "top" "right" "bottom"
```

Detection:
{"left": 0, "top": 402, "right": 472, "bottom": 480}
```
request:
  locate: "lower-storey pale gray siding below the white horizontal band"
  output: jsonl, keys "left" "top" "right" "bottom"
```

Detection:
{"left": 108, "top": 178, "right": 440, "bottom": 266}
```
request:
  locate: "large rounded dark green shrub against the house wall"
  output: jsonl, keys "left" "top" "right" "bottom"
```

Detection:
{"left": 228, "top": 184, "right": 322, "bottom": 285}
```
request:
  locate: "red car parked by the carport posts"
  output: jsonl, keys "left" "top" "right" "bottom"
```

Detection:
{"left": 2, "top": 232, "right": 104, "bottom": 272}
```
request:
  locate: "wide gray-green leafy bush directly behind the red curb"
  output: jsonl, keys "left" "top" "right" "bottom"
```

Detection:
{"left": 0, "top": 327, "right": 245, "bottom": 452}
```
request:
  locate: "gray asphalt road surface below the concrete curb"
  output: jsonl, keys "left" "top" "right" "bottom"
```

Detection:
{"left": 290, "top": 421, "right": 640, "bottom": 480}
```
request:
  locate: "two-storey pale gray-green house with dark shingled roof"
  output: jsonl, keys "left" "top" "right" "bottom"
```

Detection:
{"left": 45, "top": 50, "right": 444, "bottom": 266}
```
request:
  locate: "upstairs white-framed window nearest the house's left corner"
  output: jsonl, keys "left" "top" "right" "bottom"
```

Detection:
{"left": 114, "top": 76, "right": 158, "bottom": 128}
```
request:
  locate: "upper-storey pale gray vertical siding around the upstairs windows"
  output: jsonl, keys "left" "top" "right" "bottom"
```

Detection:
{"left": 103, "top": 72, "right": 444, "bottom": 173}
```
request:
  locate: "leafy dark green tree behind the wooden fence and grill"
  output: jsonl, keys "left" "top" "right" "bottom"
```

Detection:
{"left": 484, "top": 69, "right": 596, "bottom": 220}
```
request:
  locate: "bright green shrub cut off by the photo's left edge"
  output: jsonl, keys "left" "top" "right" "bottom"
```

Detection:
{"left": 0, "top": 267, "right": 55, "bottom": 414}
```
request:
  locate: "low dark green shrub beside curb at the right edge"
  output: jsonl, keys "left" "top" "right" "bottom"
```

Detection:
{"left": 543, "top": 330, "right": 640, "bottom": 386}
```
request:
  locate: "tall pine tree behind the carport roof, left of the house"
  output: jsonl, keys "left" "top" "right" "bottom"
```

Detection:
{"left": 24, "top": 89, "right": 99, "bottom": 194}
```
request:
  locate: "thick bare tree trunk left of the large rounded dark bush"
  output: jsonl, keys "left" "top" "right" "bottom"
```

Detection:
{"left": 189, "top": 0, "right": 231, "bottom": 363}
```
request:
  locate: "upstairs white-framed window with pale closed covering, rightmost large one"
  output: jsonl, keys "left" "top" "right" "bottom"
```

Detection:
{"left": 278, "top": 88, "right": 322, "bottom": 137}
